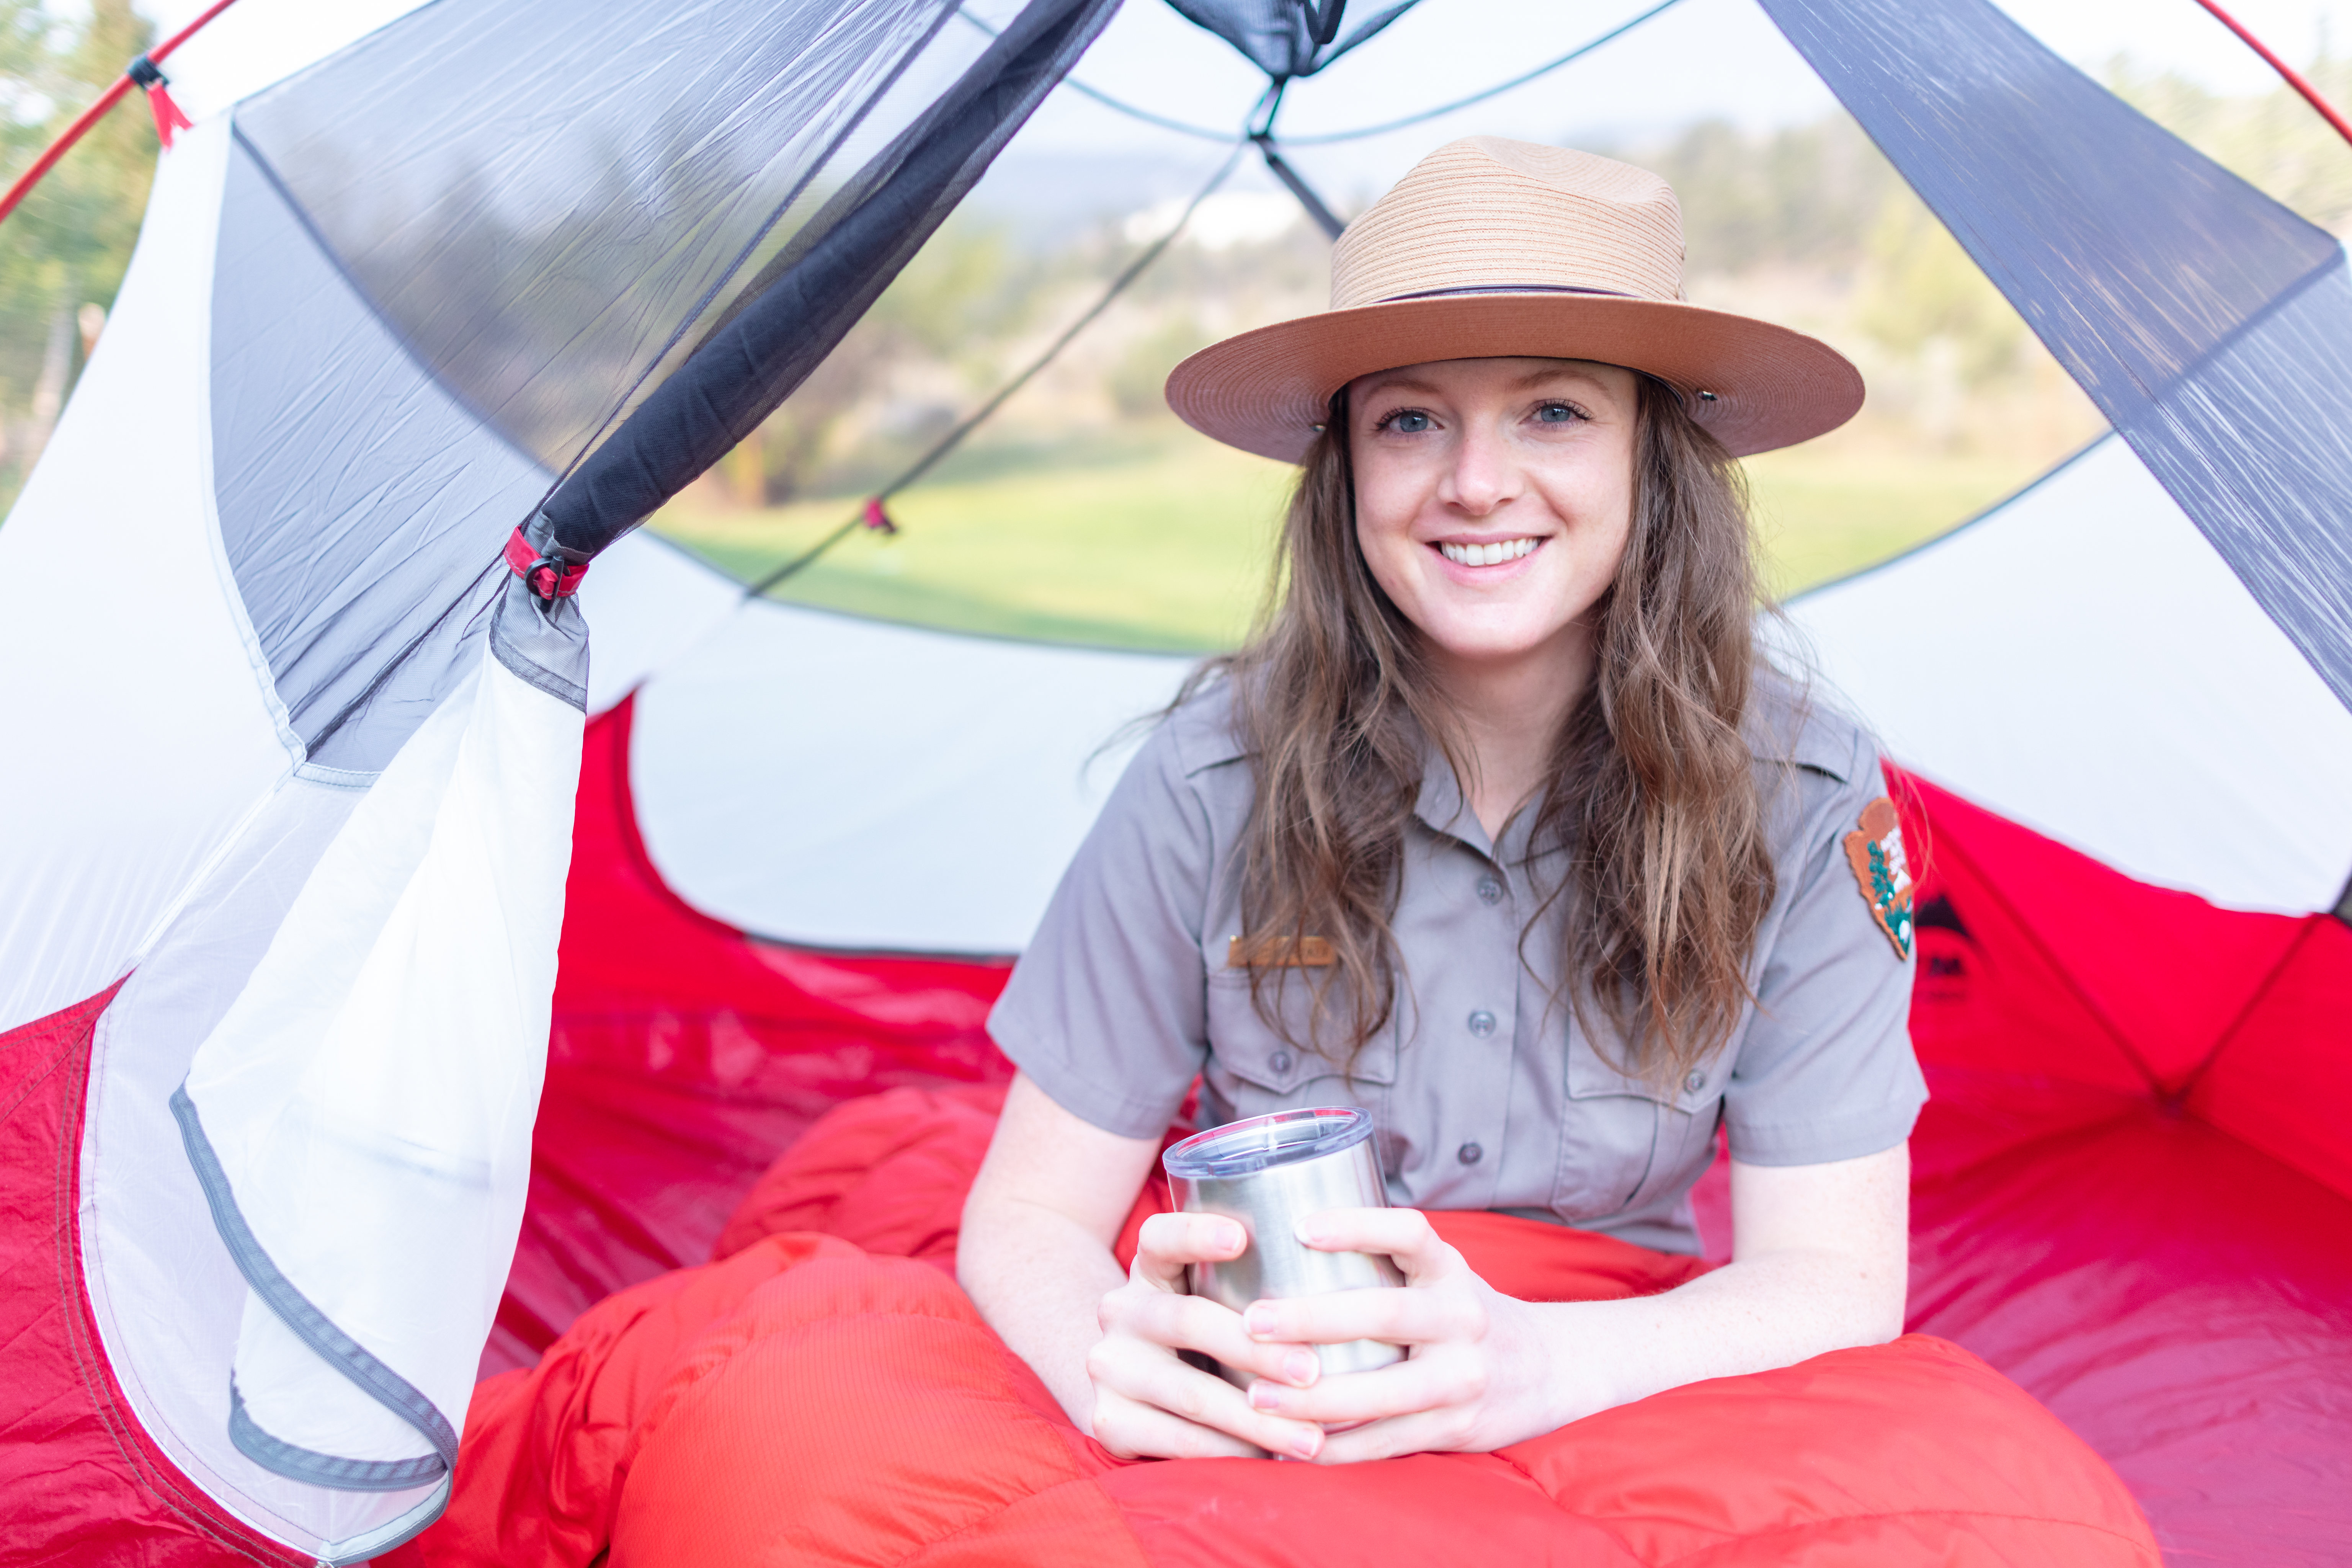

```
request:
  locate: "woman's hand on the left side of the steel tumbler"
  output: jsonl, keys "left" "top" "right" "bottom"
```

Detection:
{"left": 1087, "top": 1213, "right": 1336, "bottom": 1460}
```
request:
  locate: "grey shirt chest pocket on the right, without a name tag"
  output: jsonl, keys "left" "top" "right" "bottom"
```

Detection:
{"left": 1552, "top": 1025, "right": 1729, "bottom": 1222}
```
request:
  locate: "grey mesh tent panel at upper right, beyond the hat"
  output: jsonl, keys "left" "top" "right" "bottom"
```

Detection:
{"left": 1764, "top": 0, "right": 2352, "bottom": 703}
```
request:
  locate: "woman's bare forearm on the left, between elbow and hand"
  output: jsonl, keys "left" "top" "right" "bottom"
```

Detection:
{"left": 955, "top": 1199, "right": 1127, "bottom": 1434}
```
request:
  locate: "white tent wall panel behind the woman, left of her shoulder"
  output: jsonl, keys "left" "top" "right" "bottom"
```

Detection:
{"left": 630, "top": 576, "right": 1195, "bottom": 954}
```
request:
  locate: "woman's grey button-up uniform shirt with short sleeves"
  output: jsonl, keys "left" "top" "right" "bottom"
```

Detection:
{"left": 988, "top": 679, "right": 1926, "bottom": 1253}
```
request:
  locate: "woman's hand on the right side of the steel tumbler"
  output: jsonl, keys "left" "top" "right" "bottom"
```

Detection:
{"left": 1242, "top": 1208, "right": 1583, "bottom": 1465}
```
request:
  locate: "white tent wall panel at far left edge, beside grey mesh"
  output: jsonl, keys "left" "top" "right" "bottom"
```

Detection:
{"left": 0, "top": 124, "right": 299, "bottom": 1030}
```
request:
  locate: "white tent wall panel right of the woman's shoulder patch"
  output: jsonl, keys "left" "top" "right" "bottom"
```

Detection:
{"left": 1790, "top": 435, "right": 2352, "bottom": 915}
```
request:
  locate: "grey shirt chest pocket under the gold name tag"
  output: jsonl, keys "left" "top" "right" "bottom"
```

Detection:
{"left": 1202, "top": 969, "right": 1397, "bottom": 1129}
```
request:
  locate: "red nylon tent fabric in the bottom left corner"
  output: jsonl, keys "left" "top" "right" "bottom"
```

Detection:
{"left": 0, "top": 980, "right": 310, "bottom": 1568}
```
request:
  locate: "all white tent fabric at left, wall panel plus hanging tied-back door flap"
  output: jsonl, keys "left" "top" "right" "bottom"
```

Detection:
{"left": 0, "top": 120, "right": 581, "bottom": 1561}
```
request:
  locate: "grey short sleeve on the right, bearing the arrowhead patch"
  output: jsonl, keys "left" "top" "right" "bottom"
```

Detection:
{"left": 1724, "top": 736, "right": 1926, "bottom": 1166}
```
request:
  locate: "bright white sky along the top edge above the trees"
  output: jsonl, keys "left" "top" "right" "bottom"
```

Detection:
{"left": 141, "top": 0, "right": 2352, "bottom": 221}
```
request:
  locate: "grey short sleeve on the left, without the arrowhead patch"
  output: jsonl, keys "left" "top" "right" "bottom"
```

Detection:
{"left": 988, "top": 719, "right": 1216, "bottom": 1138}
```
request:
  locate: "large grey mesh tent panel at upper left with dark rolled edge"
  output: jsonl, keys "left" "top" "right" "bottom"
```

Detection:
{"left": 212, "top": 0, "right": 1117, "bottom": 773}
